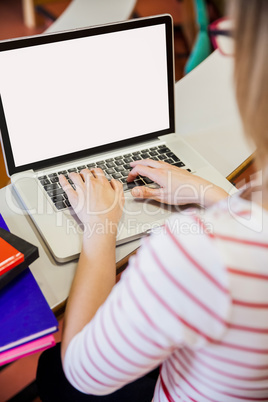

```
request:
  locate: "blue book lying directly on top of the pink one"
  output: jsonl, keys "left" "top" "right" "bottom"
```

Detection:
{"left": 0, "top": 215, "right": 58, "bottom": 353}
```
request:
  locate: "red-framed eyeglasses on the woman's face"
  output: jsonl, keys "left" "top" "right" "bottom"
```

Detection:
{"left": 209, "top": 18, "right": 234, "bottom": 56}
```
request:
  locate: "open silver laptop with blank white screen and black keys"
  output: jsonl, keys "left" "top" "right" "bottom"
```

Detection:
{"left": 0, "top": 15, "right": 233, "bottom": 262}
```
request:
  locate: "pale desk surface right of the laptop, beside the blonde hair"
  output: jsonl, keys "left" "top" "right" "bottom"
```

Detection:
{"left": 175, "top": 51, "right": 255, "bottom": 177}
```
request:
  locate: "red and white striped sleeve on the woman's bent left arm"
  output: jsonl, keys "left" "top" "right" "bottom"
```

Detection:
{"left": 64, "top": 210, "right": 230, "bottom": 395}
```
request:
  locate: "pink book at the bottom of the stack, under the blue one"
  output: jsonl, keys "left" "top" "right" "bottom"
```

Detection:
{"left": 0, "top": 335, "right": 56, "bottom": 366}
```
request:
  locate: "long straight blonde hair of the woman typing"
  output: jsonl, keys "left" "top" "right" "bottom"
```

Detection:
{"left": 230, "top": 0, "right": 268, "bottom": 167}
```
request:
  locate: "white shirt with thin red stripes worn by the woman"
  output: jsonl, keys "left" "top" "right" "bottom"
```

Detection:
{"left": 64, "top": 196, "right": 268, "bottom": 402}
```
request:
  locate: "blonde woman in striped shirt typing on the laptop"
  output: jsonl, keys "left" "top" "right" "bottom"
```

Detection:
{"left": 37, "top": 0, "right": 268, "bottom": 402}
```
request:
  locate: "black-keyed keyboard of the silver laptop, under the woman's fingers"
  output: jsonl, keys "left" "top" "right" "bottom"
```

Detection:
{"left": 38, "top": 145, "right": 191, "bottom": 210}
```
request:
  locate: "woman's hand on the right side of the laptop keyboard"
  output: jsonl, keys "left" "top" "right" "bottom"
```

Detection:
{"left": 127, "top": 159, "right": 228, "bottom": 207}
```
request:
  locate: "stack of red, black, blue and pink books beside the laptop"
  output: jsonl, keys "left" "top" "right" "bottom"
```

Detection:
{"left": 0, "top": 215, "right": 58, "bottom": 366}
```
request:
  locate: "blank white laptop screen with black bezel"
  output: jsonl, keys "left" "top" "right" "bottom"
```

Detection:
{"left": 0, "top": 16, "right": 174, "bottom": 173}
